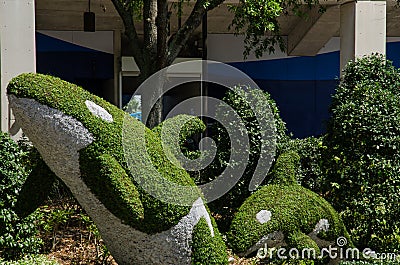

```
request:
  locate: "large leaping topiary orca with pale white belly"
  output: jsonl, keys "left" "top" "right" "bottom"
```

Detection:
{"left": 8, "top": 74, "right": 227, "bottom": 265}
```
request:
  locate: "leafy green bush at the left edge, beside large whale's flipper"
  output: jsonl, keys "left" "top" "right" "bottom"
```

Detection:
{"left": 0, "top": 133, "right": 42, "bottom": 260}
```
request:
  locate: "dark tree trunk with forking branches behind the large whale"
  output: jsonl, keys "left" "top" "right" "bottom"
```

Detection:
{"left": 111, "top": 0, "right": 224, "bottom": 128}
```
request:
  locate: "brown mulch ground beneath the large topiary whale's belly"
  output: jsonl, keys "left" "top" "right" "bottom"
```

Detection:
{"left": 40, "top": 199, "right": 257, "bottom": 265}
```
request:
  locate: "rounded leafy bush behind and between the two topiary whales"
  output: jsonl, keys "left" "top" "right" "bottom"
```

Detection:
{"left": 201, "top": 87, "right": 289, "bottom": 226}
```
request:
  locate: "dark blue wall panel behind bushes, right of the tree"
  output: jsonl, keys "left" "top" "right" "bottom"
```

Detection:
{"left": 230, "top": 42, "right": 400, "bottom": 138}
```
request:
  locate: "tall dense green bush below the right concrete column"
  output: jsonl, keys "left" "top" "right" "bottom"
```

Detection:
{"left": 325, "top": 55, "right": 400, "bottom": 251}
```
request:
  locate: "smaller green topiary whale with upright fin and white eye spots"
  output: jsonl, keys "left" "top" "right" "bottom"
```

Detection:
{"left": 228, "top": 152, "right": 351, "bottom": 262}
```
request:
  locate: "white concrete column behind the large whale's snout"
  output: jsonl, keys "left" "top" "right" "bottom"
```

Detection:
{"left": 0, "top": 0, "right": 36, "bottom": 132}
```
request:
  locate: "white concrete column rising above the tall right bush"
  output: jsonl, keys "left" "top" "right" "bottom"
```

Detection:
{"left": 340, "top": 1, "right": 386, "bottom": 72}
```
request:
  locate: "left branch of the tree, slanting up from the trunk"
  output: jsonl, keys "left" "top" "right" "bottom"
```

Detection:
{"left": 111, "top": 0, "right": 145, "bottom": 69}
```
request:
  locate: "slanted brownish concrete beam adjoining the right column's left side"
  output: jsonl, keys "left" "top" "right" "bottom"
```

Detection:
{"left": 288, "top": 6, "right": 340, "bottom": 56}
